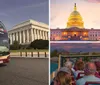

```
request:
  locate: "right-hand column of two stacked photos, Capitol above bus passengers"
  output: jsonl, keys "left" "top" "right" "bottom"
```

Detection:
{"left": 50, "top": 0, "right": 100, "bottom": 85}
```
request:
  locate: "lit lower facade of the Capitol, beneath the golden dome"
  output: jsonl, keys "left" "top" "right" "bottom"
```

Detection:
{"left": 50, "top": 28, "right": 100, "bottom": 41}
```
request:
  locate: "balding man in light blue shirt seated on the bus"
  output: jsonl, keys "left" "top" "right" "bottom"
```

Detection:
{"left": 76, "top": 62, "right": 100, "bottom": 85}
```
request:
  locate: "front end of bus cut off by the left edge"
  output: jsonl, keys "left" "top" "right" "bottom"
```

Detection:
{"left": 0, "top": 21, "right": 10, "bottom": 64}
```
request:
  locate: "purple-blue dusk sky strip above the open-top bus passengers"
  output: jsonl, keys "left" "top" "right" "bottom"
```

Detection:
{"left": 51, "top": 43, "right": 100, "bottom": 52}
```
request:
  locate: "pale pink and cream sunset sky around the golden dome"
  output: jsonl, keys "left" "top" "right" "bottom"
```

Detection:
{"left": 50, "top": 0, "right": 100, "bottom": 29}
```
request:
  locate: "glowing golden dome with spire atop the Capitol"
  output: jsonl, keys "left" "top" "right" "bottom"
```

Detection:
{"left": 67, "top": 3, "right": 84, "bottom": 29}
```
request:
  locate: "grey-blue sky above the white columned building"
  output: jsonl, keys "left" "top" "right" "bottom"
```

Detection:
{"left": 0, "top": 0, "right": 49, "bottom": 30}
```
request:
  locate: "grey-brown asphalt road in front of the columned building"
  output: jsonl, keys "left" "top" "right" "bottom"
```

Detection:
{"left": 0, "top": 58, "right": 49, "bottom": 85}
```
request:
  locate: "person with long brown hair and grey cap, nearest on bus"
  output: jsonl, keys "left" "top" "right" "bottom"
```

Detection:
{"left": 52, "top": 67, "right": 73, "bottom": 85}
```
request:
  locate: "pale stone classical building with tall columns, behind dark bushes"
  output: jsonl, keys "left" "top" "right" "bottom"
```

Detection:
{"left": 8, "top": 19, "right": 49, "bottom": 45}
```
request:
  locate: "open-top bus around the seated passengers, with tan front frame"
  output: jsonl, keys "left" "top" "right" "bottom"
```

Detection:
{"left": 50, "top": 54, "right": 100, "bottom": 85}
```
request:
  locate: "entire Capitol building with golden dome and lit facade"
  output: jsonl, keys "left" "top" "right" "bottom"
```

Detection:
{"left": 50, "top": 3, "right": 100, "bottom": 41}
